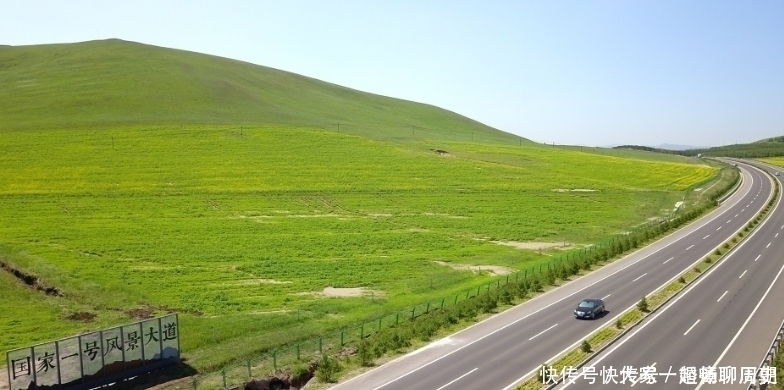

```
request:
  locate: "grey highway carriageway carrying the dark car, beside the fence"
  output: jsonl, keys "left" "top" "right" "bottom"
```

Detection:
{"left": 334, "top": 162, "right": 771, "bottom": 390}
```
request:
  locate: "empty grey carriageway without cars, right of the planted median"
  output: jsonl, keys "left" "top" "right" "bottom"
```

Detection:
{"left": 560, "top": 160, "right": 784, "bottom": 389}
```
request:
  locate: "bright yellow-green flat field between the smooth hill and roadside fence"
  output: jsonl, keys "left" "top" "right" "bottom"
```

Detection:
{"left": 0, "top": 126, "right": 716, "bottom": 369}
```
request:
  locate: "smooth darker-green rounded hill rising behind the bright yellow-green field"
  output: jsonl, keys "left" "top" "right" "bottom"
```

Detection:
{"left": 0, "top": 39, "right": 519, "bottom": 143}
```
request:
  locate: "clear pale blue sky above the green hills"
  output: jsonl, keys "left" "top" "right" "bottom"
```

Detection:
{"left": 0, "top": 0, "right": 784, "bottom": 146}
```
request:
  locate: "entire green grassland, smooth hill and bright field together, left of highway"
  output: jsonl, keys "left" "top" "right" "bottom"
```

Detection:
{"left": 0, "top": 40, "right": 717, "bottom": 369}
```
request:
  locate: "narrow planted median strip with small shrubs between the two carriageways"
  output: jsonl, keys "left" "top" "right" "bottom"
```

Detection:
{"left": 517, "top": 165, "right": 780, "bottom": 390}
